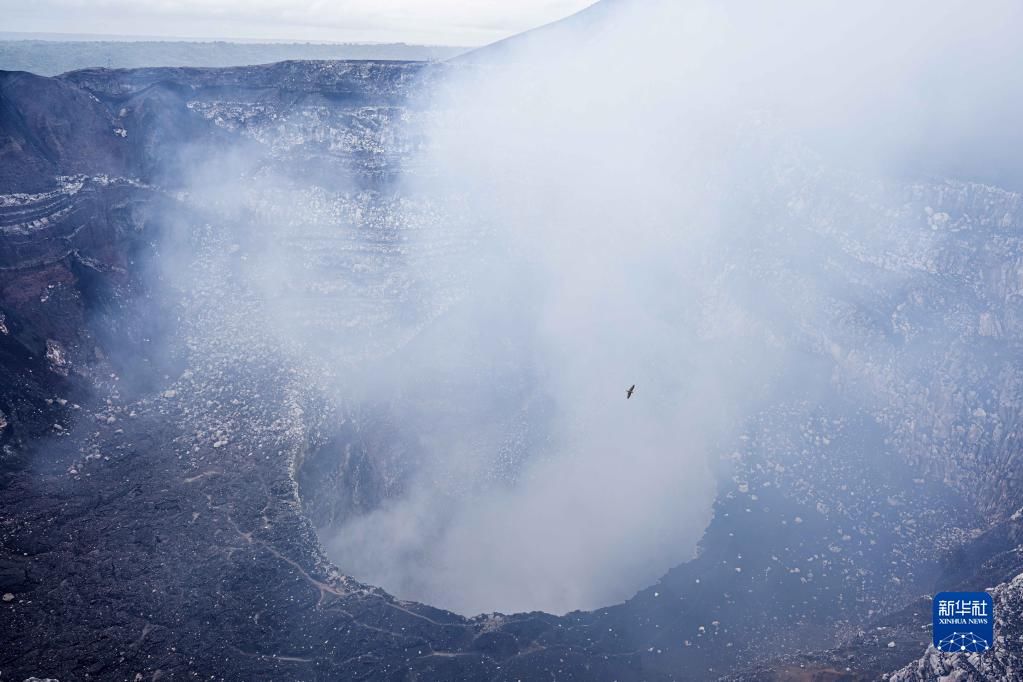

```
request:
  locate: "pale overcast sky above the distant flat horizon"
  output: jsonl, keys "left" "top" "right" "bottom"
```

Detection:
{"left": 0, "top": 0, "right": 593, "bottom": 45}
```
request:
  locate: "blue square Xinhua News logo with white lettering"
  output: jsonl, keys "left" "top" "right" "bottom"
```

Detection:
{"left": 934, "top": 592, "right": 994, "bottom": 653}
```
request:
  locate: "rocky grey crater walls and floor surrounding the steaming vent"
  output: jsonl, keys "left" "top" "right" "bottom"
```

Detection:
{"left": 0, "top": 54, "right": 1023, "bottom": 680}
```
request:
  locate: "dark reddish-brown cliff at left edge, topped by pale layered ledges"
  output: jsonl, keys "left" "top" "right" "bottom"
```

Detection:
{"left": 0, "top": 176, "right": 167, "bottom": 447}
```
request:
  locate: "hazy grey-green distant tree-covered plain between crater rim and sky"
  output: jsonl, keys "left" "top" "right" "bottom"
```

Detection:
{"left": 0, "top": 40, "right": 466, "bottom": 76}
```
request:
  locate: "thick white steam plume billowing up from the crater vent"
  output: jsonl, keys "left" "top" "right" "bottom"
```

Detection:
{"left": 171, "top": 0, "right": 1023, "bottom": 613}
